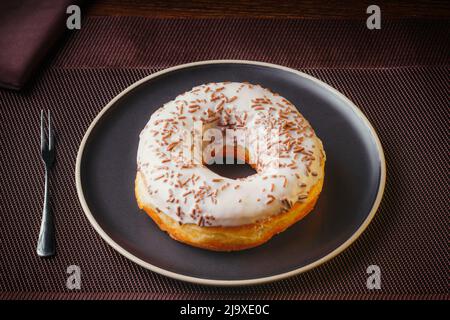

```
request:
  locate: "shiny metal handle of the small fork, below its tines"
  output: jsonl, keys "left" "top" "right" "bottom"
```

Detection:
{"left": 37, "top": 168, "right": 56, "bottom": 257}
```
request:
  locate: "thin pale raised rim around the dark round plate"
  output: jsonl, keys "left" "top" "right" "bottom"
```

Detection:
{"left": 75, "top": 59, "right": 386, "bottom": 286}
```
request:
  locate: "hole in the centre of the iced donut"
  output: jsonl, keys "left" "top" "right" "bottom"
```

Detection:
{"left": 204, "top": 146, "right": 257, "bottom": 179}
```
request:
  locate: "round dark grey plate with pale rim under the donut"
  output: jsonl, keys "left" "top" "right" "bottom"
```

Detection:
{"left": 76, "top": 61, "right": 385, "bottom": 285}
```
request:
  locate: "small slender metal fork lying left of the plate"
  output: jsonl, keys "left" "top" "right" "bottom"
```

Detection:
{"left": 37, "top": 110, "right": 56, "bottom": 257}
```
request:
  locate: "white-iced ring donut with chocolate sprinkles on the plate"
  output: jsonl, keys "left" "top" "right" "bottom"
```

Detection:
{"left": 135, "top": 82, "right": 326, "bottom": 251}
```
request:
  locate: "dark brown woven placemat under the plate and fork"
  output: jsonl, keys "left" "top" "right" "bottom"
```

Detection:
{"left": 0, "top": 17, "right": 450, "bottom": 299}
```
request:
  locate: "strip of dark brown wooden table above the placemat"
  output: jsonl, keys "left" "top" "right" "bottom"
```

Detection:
{"left": 88, "top": 0, "right": 450, "bottom": 19}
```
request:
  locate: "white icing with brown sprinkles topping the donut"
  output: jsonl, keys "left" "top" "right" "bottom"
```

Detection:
{"left": 137, "top": 82, "right": 325, "bottom": 226}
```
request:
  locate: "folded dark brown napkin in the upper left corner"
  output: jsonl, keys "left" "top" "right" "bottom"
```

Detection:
{"left": 0, "top": 0, "right": 80, "bottom": 89}
